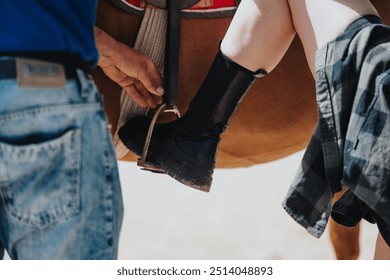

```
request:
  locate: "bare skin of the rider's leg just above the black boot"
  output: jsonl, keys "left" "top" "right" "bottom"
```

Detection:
{"left": 221, "top": 0, "right": 295, "bottom": 72}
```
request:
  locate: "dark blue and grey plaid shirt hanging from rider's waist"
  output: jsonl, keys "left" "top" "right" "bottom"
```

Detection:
{"left": 283, "top": 16, "right": 390, "bottom": 242}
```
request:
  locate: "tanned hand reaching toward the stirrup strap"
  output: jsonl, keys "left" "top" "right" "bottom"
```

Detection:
{"left": 95, "top": 27, "right": 164, "bottom": 108}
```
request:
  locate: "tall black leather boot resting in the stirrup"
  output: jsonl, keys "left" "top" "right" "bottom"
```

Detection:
{"left": 119, "top": 52, "right": 266, "bottom": 192}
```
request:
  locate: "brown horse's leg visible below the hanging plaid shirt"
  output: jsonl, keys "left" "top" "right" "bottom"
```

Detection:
{"left": 329, "top": 189, "right": 360, "bottom": 260}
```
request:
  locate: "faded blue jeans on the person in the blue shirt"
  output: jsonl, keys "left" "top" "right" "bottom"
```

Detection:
{"left": 0, "top": 57, "right": 123, "bottom": 260}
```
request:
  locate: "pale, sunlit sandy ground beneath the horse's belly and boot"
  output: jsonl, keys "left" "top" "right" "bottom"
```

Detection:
{"left": 119, "top": 152, "right": 377, "bottom": 260}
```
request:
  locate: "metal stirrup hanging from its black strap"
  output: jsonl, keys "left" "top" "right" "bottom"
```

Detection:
{"left": 137, "top": 0, "right": 200, "bottom": 172}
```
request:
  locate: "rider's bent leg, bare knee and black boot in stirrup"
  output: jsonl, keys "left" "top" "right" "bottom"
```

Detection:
{"left": 119, "top": 0, "right": 295, "bottom": 191}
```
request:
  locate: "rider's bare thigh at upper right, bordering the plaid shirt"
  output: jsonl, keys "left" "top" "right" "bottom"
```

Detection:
{"left": 288, "top": 0, "right": 378, "bottom": 75}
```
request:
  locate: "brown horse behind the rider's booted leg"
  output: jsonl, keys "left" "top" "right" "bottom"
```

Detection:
{"left": 94, "top": 0, "right": 390, "bottom": 259}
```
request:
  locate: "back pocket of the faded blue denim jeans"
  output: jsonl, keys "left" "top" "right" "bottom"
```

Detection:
{"left": 0, "top": 129, "right": 81, "bottom": 228}
